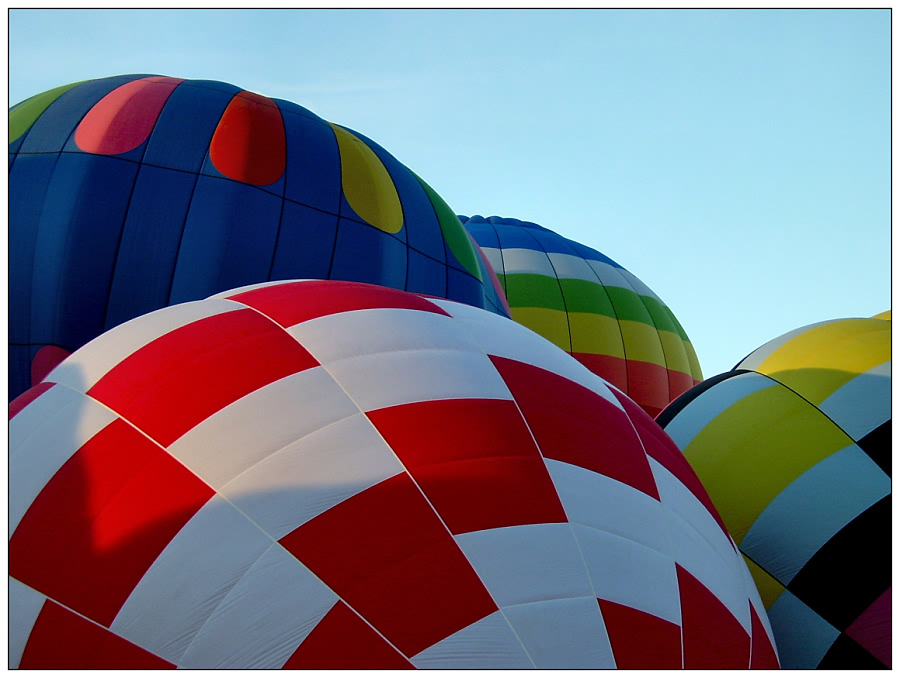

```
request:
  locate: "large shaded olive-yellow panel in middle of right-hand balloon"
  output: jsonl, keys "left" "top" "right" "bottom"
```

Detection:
{"left": 684, "top": 384, "right": 853, "bottom": 544}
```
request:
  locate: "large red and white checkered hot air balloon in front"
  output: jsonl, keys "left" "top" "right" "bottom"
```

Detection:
{"left": 9, "top": 281, "right": 778, "bottom": 669}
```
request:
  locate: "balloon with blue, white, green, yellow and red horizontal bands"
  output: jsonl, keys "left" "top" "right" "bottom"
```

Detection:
{"left": 460, "top": 215, "right": 703, "bottom": 416}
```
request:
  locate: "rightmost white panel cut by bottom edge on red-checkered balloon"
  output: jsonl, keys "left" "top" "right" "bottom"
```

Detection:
{"left": 503, "top": 598, "right": 616, "bottom": 669}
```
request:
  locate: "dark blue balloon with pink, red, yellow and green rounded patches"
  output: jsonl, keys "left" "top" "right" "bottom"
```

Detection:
{"left": 9, "top": 75, "right": 505, "bottom": 404}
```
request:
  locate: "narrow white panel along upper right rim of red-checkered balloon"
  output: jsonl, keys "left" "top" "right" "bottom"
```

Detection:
{"left": 431, "top": 299, "right": 624, "bottom": 410}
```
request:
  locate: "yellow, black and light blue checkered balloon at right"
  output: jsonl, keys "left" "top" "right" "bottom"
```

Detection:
{"left": 657, "top": 312, "right": 891, "bottom": 669}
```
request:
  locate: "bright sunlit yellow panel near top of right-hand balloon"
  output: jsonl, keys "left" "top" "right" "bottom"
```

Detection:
{"left": 756, "top": 318, "right": 891, "bottom": 405}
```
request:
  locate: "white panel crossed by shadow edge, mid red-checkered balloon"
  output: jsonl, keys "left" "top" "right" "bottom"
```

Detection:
{"left": 221, "top": 414, "right": 403, "bottom": 539}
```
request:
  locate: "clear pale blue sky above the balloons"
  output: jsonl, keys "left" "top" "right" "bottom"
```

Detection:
{"left": 9, "top": 9, "right": 891, "bottom": 377}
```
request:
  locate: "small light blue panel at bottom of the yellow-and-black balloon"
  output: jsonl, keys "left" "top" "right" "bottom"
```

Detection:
{"left": 767, "top": 591, "right": 840, "bottom": 669}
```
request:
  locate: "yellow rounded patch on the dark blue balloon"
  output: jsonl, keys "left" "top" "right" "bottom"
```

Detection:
{"left": 328, "top": 123, "right": 403, "bottom": 233}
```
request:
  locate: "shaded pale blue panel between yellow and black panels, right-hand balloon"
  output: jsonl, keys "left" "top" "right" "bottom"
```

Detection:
{"left": 740, "top": 445, "right": 891, "bottom": 585}
